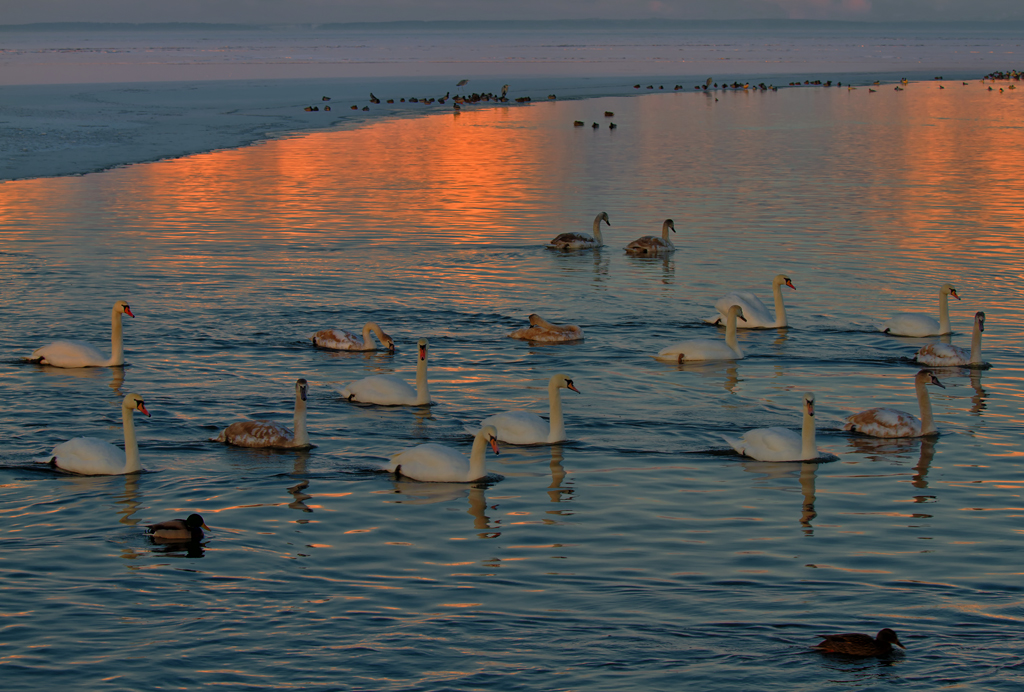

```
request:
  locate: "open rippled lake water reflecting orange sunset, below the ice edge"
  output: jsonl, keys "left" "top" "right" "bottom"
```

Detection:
{"left": 0, "top": 82, "right": 1024, "bottom": 691}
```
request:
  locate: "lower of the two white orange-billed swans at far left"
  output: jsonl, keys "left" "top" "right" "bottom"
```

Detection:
{"left": 49, "top": 394, "right": 150, "bottom": 476}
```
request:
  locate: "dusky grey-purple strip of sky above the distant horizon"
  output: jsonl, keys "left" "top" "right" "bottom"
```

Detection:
{"left": 6, "top": 0, "right": 1024, "bottom": 24}
